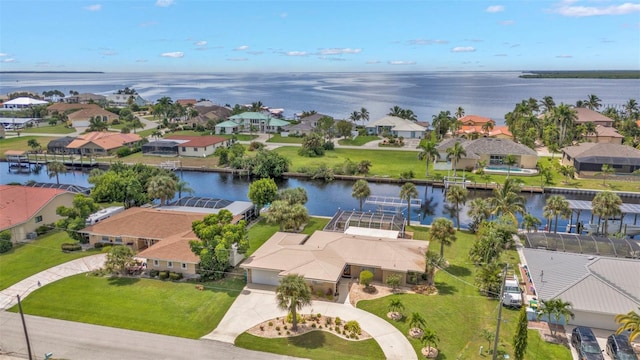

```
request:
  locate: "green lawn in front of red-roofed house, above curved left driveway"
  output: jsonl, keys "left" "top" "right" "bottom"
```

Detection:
{"left": 0, "top": 231, "right": 98, "bottom": 290}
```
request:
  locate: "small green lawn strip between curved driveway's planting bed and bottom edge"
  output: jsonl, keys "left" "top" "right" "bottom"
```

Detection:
{"left": 235, "top": 331, "right": 385, "bottom": 360}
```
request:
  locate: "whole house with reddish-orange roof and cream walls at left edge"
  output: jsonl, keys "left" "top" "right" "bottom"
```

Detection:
{"left": 0, "top": 185, "right": 76, "bottom": 242}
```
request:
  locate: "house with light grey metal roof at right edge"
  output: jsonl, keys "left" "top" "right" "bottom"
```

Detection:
{"left": 523, "top": 249, "right": 640, "bottom": 331}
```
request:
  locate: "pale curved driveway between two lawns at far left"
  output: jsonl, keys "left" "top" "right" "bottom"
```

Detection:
{"left": 0, "top": 254, "right": 107, "bottom": 310}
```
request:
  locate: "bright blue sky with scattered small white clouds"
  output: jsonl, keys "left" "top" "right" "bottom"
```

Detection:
{"left": 0, "top": 0, "right": 640, "bottom": 72}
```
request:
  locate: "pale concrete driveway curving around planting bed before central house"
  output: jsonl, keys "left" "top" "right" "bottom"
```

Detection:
{"left": 202, "top": 284, "right": 417, "bottom": 360}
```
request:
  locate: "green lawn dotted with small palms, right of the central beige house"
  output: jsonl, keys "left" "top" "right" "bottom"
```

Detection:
{"left": 358, "top": 227, "right": 571, "bottom": 360}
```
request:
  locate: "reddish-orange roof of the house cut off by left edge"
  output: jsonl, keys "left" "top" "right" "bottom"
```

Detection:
{"left": 0, "top": 185, "right": 66, "bottom": 229}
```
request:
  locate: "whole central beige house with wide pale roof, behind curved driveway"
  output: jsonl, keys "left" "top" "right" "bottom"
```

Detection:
{"left": 240, "top": 231, "right": 428, "bottom": 295}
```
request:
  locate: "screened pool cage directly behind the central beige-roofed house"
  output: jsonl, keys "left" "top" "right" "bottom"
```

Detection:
{"left": 324, "top": 210, "right": 404, "bottom": 237}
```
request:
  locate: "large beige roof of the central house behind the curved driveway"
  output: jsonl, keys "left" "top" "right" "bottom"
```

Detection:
{"left": 241, "top": 231, "right": 429, "bottom": 282}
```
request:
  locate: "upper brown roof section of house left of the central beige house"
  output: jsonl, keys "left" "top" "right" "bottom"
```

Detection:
{"left": 81, "top": 207, "right": 207, "bottom": 240}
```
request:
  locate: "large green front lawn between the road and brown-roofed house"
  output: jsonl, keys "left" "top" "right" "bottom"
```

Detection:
{"left": 10, "top": 274, "right": 245, "bottom": 339}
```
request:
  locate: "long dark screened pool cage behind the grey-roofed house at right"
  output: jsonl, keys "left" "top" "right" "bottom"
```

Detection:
{"left": 524, "top": 232, "right": 640, "bottom": 259}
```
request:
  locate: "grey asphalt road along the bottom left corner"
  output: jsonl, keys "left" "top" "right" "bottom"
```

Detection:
{"left": 0, "top": 311, "right": 294, "bottom": 360}
